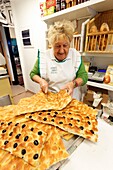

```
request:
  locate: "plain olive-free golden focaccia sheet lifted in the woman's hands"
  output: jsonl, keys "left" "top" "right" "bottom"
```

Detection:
{"left": 14, "top": 90, "right": 72, "bottom": 115}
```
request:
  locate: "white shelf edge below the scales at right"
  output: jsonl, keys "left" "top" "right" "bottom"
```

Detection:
{"left": 87, "top": 81, "right": 113, "bottom": 91}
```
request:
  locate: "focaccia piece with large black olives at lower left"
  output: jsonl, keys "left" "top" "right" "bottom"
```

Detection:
{"left": 0, "top": 123, "right": 47, "bottom": 166}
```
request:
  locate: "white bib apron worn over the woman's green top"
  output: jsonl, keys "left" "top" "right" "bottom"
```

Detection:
{"left": 38, "top": 48, "right": 81, "bottom": 100}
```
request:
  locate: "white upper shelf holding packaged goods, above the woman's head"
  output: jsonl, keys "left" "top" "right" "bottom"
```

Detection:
{"left": 42, "top": 0, "right": 113, "bottom": 24}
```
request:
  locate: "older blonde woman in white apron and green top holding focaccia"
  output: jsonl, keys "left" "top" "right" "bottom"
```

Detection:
{"left": 30, "top": 20, "right": 88, "bottom": 100}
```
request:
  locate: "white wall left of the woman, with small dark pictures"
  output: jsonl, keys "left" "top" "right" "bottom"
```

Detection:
{"left": 11, "top": 0, "right": 46, "bottom": 93}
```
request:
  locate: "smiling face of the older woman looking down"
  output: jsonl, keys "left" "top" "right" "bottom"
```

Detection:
{"left": 53, "top": 38, "right": 70, "bottom": 61}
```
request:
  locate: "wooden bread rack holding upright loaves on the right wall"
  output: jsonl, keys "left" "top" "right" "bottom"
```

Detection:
{"left": 85, "top": 9, "right": 113, "bottom": 54}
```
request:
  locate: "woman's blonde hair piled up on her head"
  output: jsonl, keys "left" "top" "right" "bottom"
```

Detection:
{"left": 48, "top": 20, "right": 74, "bottom": 45}
